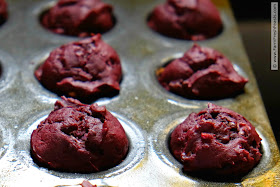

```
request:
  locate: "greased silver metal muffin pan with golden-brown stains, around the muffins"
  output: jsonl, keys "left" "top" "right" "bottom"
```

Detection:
{"left": 0, "top": 0, "right": 280, "bottom": 187}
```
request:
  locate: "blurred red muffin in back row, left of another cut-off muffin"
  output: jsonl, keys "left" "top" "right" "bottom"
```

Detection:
{"left": 41, "top": 0, "right": 114, "bottom": 37}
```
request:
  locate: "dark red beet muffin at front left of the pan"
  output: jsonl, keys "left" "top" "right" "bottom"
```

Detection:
{"left": 31, "top": 97, "right": 129, "bottom": 173}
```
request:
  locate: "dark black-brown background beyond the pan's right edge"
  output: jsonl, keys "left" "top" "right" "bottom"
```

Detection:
{"left": 230, "top": 0, "right": 280, "bottom": 146}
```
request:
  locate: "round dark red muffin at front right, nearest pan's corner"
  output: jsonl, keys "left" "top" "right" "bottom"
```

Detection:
{"left": 170, "top": 103, "right": 262, "bottom": 175}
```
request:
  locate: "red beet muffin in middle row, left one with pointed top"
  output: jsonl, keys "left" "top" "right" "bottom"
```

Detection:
{"left": 35, "top": 34, "right": 122, "bottom": 101}
